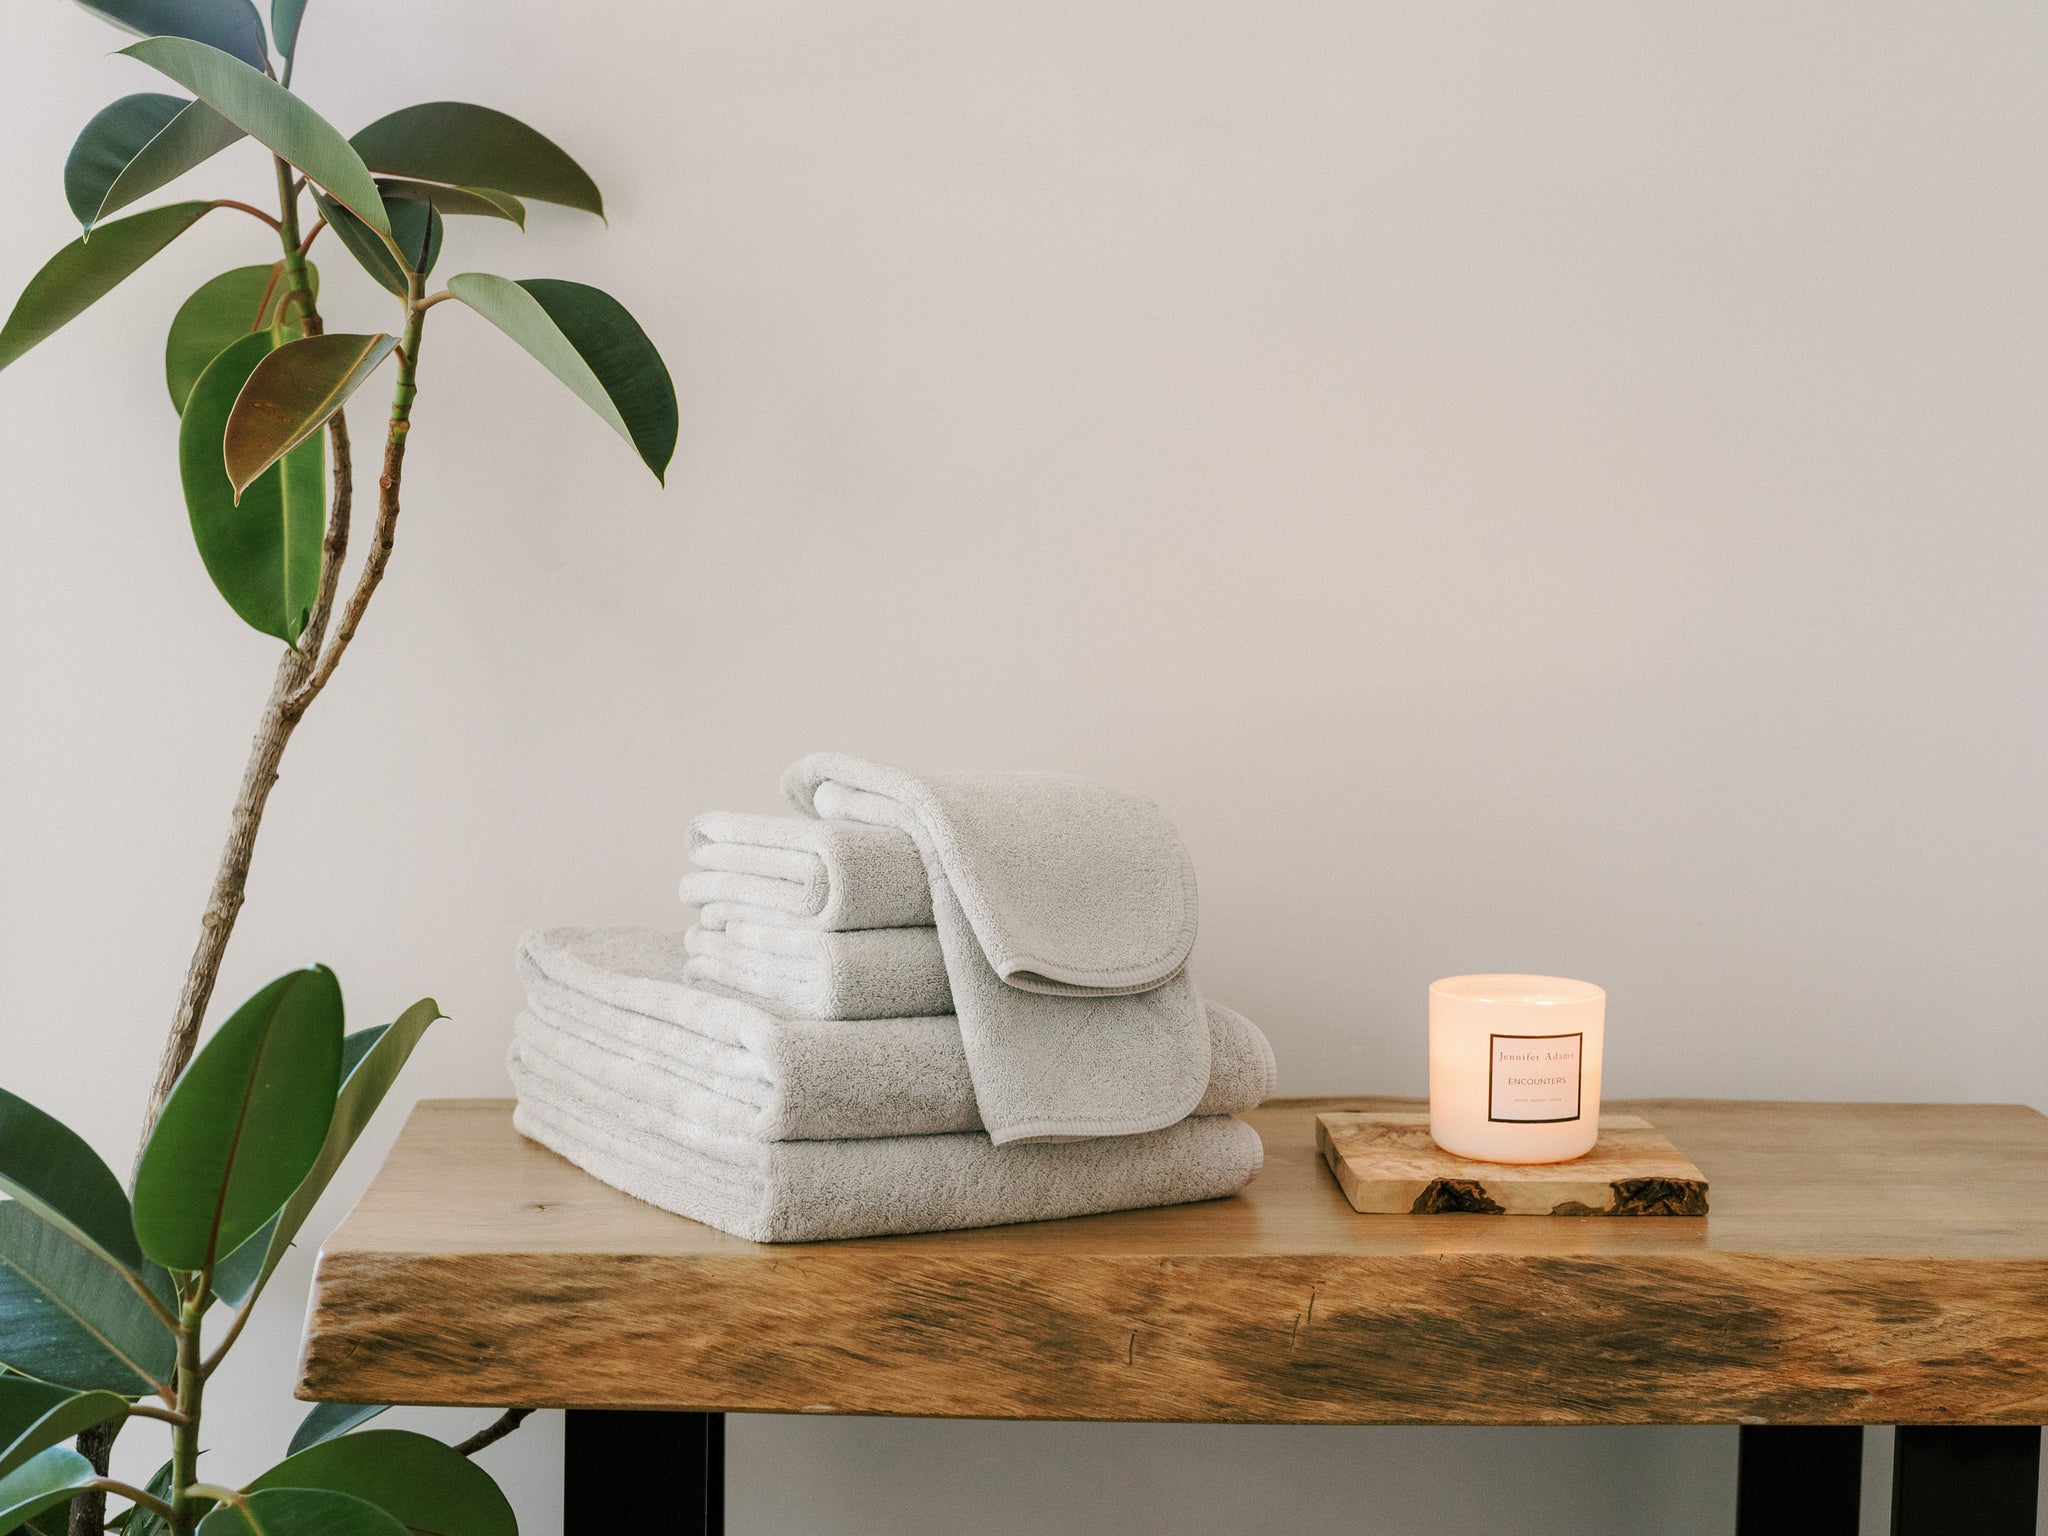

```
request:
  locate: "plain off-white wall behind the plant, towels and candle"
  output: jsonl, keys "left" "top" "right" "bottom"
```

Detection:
{"left": 0, "top": 0, "right": 2048, "bottom": 1536}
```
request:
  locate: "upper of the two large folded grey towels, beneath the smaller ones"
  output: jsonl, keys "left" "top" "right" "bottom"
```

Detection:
{"left": 516, "top": 928, "right": 1274, "bottom": 1141}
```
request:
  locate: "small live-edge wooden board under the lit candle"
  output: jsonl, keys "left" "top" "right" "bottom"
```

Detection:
{"left": 1315, "top": 1110, "right": 1706, "bottom": 1217}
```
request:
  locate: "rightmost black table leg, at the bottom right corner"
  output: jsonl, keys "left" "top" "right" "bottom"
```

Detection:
{"left": 1892, "top": 1423, "right": 2042, "bottom": 1536}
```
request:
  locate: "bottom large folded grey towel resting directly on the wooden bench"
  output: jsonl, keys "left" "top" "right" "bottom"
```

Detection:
{"left": 510, "top": 1042, "right": 1266, "bottom": 1243}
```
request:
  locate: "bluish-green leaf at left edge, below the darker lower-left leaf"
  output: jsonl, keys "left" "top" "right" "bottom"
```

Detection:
{"left": 0, "top": 1200, "right": 178, "bottom": 1397}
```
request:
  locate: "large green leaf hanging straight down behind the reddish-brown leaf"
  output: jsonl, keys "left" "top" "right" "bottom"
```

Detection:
{"left": 180, "top": 330, "right": 328, "bottom": 647}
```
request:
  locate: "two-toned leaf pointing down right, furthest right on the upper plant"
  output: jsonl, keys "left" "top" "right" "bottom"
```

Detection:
{"left": 449, "top": 272, "right": 676, "bottom": 479}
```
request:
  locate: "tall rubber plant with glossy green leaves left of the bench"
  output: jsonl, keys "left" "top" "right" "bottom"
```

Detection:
{"left": 0, "top": 0, "right": 676, "bottom": 1536}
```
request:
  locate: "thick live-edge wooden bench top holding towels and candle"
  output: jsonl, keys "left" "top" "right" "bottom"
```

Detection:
{"left": 299, "top": 1100, "right": 2048, "bottom": 1423}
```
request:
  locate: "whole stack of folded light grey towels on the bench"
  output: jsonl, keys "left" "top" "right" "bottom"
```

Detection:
{"left": 510, "top": 754, "right": 1274, "bottom": 1241}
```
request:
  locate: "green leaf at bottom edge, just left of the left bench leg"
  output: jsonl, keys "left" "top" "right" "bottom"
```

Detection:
{"left": 250, "top": 1430, "right": 518, "bottom": 1536}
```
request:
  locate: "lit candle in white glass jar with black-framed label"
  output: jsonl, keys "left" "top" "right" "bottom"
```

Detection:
{"left": 1430, "top": 977, "right": 1608, "bottom": 1163}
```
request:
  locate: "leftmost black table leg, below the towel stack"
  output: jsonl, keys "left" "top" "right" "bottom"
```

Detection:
{"left": 561, "top": 1409, "right": 725, "bottom": 1536}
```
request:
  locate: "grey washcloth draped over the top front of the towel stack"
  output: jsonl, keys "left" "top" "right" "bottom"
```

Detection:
{"left": 782, "top": 754, "right": 1208, "bottom": 1145}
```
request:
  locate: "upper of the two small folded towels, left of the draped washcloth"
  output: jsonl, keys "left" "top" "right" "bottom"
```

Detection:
{"left": 680, "top": 811, "right": 932, "bottom": 934}
